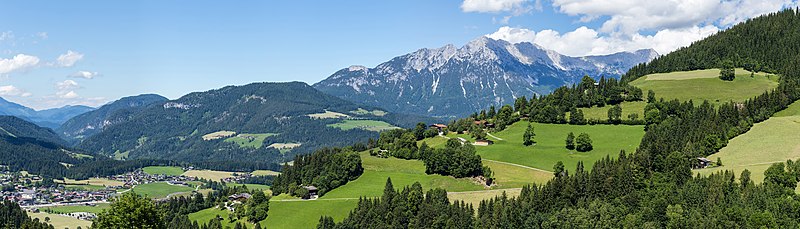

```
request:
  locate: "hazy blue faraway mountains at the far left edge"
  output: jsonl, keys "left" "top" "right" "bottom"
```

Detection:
{"left": 0, "top": 98, "right": 94, "bottom": 129}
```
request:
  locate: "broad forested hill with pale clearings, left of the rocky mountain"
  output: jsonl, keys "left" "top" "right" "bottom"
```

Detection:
{"left": 78, "top": 82, "right": 432, "bottom": 170}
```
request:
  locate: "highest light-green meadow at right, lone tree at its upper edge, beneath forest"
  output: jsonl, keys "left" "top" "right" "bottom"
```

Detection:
{"left": 623, "top": 69, "right": 778, "bottom": 104}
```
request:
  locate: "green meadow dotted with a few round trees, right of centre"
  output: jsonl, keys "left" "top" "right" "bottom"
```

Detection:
{"left": 476, "top": 121, "right": 644, "bottom": 171}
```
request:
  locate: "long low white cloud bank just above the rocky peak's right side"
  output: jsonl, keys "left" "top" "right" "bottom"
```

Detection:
{"left": 486, "top": 25, "right": 719, "bottom": 56}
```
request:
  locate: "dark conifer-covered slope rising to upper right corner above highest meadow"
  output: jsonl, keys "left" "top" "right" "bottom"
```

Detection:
{"left": 622, "top": 9, "right": 800, "bottom": 82}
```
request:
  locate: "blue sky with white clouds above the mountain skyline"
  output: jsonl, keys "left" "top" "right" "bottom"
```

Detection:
{"left": 0, "top": 0, "right": 797, "bottom": 109}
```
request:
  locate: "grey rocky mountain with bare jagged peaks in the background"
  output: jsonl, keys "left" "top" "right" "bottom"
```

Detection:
{"left": 314, "top": 37, "right": 658, "bottom": 118}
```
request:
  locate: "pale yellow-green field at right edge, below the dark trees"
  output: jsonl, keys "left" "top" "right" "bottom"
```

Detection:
{"left": 695, "top": 102, "right": 800, "bottom": 183}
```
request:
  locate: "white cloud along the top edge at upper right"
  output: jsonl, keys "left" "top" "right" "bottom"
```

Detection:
{"left": 553, "top": 0, "right": 798, "bottom": 35}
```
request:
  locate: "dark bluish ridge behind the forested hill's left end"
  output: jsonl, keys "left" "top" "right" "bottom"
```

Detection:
{"left": 56, "top": 94, "right": 167, "bottom": 141}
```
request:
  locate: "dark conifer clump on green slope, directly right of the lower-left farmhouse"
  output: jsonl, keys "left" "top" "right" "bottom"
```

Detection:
{"left": 272, "top": 148, "right": 364, "bottom": 197}
